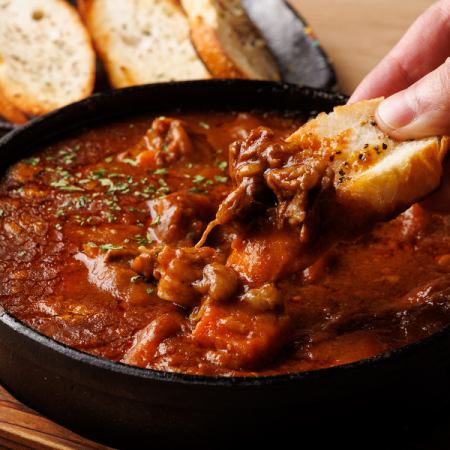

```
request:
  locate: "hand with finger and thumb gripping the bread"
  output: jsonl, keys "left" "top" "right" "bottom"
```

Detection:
{"left": 350, "top": 0, "right": 450, "bottom": 140}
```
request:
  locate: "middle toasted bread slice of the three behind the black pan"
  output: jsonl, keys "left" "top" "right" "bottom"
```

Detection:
{"left": 80, "top": 0, "right": 210, "bottom": 88}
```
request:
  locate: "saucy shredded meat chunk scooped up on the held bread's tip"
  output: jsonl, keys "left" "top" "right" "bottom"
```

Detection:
{"left": 199, "top": 127, "right": 334, "bottom": 245}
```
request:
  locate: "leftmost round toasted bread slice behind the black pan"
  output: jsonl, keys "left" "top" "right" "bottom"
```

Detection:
{"left": 0, "top": 0, "right": 95, "bottom": 115}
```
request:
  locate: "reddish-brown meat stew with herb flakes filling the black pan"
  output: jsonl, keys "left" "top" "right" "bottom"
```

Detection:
{"left": 0, "top": 113, "right": 450, "bottom": 376}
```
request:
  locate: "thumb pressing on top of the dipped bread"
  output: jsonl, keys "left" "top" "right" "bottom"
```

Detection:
{"left": 376, "top": 58, "right": 450, "bottom": 140}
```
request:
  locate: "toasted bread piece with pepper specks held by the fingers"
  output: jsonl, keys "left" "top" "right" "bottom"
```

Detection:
{"left": 288, "top": 98, "right": 449, "bottom": 218}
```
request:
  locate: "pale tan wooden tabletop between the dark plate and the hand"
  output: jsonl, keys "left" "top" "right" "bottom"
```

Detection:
{"left": 290, "top": 0, "right": 434, "bottom": 94}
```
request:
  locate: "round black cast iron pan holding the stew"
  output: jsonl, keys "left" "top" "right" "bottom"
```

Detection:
{"left": 0, "top": 80, "right": 450, "bottom": 447}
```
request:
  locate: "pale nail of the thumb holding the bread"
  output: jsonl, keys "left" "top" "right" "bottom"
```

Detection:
{"left": 377, "top": 92, "right": 416, "bottom": 130}
